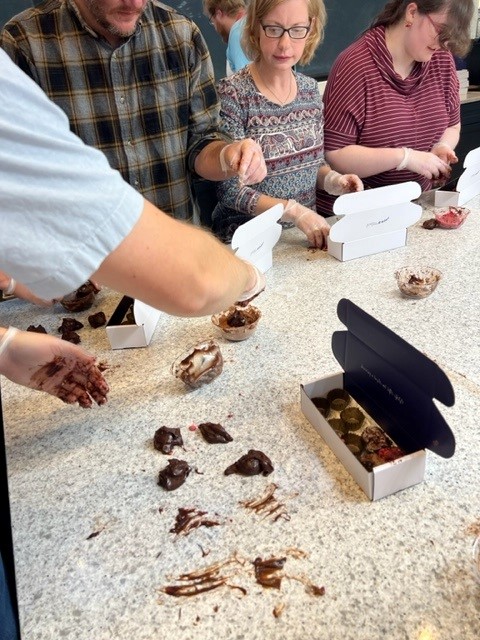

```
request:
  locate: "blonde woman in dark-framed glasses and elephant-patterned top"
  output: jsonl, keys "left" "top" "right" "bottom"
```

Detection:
{"left": 212, "top": 0, "right": 363, "bottom": 248}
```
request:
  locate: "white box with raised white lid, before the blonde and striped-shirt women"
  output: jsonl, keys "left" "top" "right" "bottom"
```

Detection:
{"left": 328, "top": 182, "right": 422, "bottom": 261}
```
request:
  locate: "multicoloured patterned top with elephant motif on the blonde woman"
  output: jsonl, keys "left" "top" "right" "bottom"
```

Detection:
{"left": 213, "top": 67, "right": 325, "bottom": 240}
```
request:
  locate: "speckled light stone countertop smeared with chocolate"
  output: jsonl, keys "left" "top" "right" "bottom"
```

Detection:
{"left": 0, "top": 199, "right": 480, "bottom": 640}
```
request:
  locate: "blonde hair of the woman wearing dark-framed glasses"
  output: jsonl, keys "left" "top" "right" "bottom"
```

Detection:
{"left": 242, "top": 0, "right": 327, "bottom": 65}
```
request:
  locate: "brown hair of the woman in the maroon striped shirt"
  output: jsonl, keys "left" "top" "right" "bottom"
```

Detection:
{"left": 371, "top": 0, "right": 473, "bottom": 57}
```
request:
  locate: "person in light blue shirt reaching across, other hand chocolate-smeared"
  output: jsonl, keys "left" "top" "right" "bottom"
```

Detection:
{"left": 0, "top": 51, "right": 265, "bottom": 640}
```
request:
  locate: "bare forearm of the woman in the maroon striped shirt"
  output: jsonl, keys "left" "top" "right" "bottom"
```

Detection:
{"left": 325, "top": 145, "right": 404, "bottom": 178}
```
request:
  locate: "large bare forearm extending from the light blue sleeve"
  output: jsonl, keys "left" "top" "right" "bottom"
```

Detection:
{"left": 92, "top": 201, "right": 256, "bottom": 316}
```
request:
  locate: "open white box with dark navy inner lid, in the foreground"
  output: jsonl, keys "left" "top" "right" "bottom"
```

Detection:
{"left": 300, "top": 299, "right": 455, "bottom": 500}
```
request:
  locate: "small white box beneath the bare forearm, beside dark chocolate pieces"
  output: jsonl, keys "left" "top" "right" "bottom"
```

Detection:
{"left": 106, "top": 296, "right": 162, "bottom": 349}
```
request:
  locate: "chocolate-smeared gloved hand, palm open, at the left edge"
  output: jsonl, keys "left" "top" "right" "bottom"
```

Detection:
{"left": 0, "top": 327, "right": 109, "bottom": 407}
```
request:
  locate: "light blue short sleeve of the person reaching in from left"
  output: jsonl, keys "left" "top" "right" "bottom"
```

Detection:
{"left": 0, "top": 50, "right": 143, "bottom": 298}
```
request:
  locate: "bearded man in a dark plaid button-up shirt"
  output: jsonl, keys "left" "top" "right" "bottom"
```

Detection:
{"left": 0, "top": 0, "right": 263, "bottom": 225}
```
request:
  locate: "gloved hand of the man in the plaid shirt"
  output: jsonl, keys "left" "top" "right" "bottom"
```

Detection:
{"left": 220, "top": 138, "right": 267, "bottom": 185}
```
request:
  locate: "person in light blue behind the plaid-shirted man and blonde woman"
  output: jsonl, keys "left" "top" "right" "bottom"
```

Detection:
{"left": 203, "top": 0, "right": 250, "bottom": 76}
